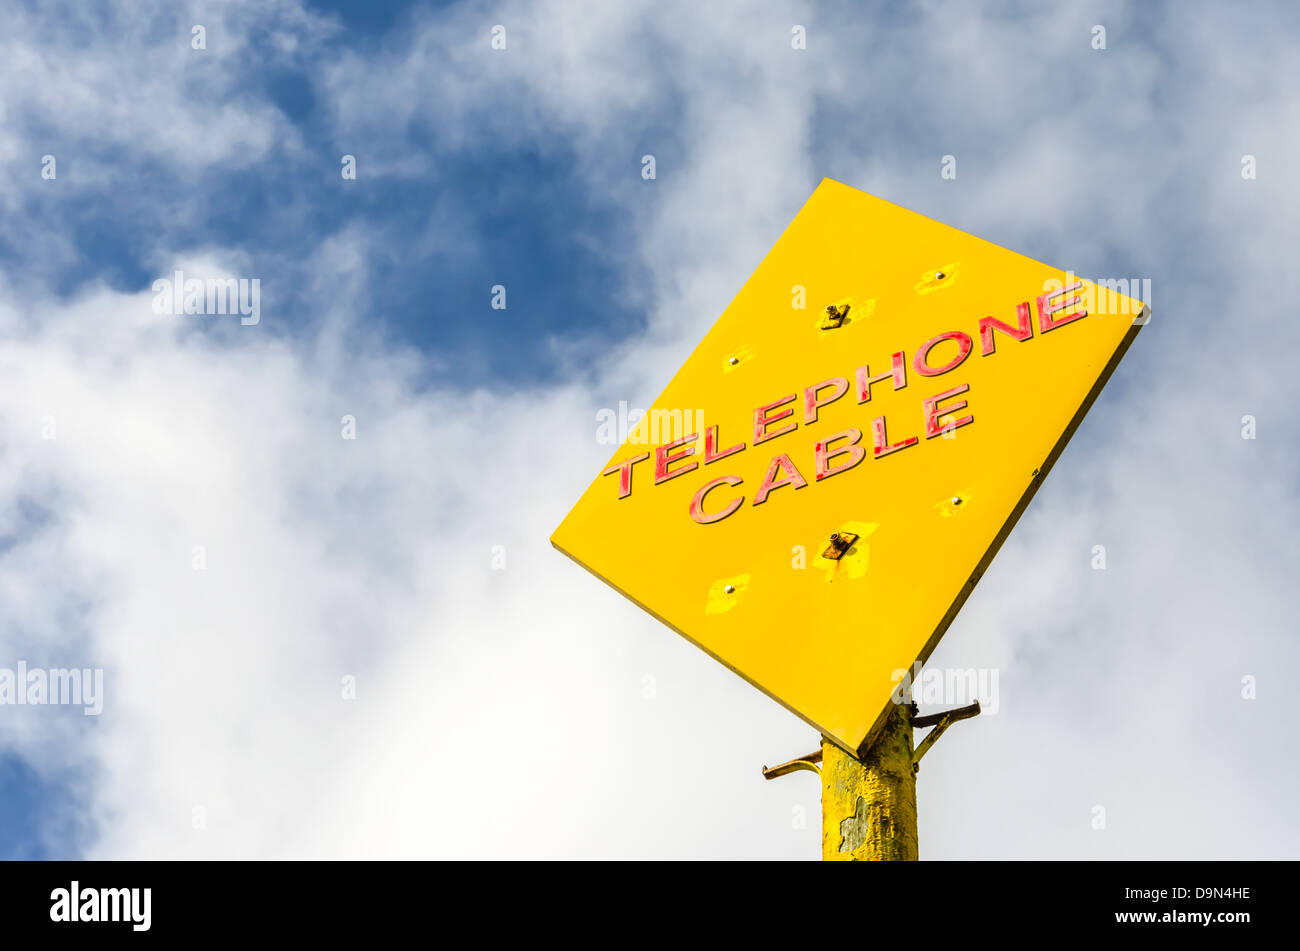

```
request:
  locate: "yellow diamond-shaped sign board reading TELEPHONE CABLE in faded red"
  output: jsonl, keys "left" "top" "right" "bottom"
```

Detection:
{"left": 551, "top": 179, "right": 1149, "bottom": 755}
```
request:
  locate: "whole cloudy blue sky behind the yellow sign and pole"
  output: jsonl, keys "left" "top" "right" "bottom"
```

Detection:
{"left": 0, "top": 0, "right": 1300, "bottom": 859}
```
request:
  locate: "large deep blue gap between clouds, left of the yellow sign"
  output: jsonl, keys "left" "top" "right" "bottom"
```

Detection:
{"left": 0, "top": 5, "right": 644, "bottom": 383}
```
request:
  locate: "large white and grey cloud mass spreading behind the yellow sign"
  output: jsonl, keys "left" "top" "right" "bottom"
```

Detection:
{"left": 0, "top": 4, "right": 1300, "bottom": 857}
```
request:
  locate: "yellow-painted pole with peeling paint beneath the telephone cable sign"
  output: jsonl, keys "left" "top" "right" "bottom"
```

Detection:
{"left": 822, "top": 703, "right": 918, "bottom": 861}
